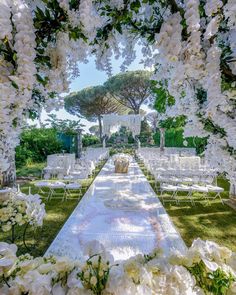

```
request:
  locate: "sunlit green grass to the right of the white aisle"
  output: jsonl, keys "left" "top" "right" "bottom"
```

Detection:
{"left": 139, "top": 163, "right": 236, "bottom": 251}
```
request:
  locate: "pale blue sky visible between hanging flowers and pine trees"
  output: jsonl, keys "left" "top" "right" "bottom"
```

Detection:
{"left": 33, "top": 48, "right": 146, "bottom": 132}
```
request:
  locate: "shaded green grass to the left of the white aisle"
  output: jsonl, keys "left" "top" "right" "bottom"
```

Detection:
{"left": 0, "top": 162, "right": 105, "bottom": 257}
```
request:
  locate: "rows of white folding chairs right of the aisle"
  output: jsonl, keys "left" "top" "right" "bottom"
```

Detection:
{"left": 136, "top": 150, "right": 224, "bottom": 204}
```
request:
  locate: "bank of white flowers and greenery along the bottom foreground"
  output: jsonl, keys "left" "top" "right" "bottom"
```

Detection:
{"left": 0, "top": 239, "right": 236, "bottom": 295}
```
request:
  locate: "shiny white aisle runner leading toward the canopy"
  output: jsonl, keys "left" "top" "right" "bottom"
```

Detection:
{"left": 45, "top": 159, "right": 186, "bottom": 260}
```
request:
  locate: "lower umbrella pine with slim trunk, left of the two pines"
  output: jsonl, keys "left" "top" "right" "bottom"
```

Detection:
{"left": 65, "top": 86, "right": 126, "bottom": 141}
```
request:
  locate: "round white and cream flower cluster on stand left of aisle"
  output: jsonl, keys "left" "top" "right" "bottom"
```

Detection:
{"left": 0, "top": 193, "right": 46, "bottom": 232}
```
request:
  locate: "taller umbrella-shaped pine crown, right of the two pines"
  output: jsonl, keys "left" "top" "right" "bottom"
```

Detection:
{"left": 104, "top": 71, "right": 152, "bottom": 114}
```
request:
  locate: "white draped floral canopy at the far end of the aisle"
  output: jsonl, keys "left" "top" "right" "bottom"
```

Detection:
{"left": 103, "top": 114, "right": 141, "bottom": 137}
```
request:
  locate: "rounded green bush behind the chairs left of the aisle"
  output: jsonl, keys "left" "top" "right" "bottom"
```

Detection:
{"left": 16, "top": 128, "right": 63, "bottom": 167}
